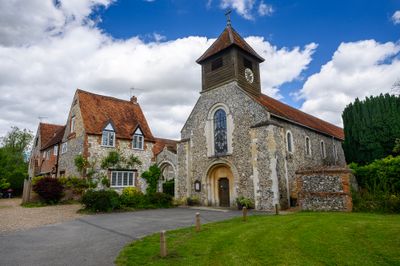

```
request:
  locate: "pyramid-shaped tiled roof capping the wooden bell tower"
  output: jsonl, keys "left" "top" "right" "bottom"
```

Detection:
{"left": 196, "top": 26, "right": 264, "bottom": 64}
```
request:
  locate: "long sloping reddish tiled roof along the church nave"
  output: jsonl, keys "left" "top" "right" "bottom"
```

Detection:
{"left": 256, "top": 94, "right": 344, "bottom": 140}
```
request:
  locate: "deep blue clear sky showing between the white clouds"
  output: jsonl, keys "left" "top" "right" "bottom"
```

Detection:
{"left": 97, "top": 0, "right": 400, "bottom": 107}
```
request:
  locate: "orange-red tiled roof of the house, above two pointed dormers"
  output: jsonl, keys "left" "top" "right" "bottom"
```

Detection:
{"left": 76, "top": 89, "right": 154, "bottom": 141}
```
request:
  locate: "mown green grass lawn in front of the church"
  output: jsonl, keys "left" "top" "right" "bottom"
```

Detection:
{"left": 116, "top": 212, "right": 400, "bottom": 266}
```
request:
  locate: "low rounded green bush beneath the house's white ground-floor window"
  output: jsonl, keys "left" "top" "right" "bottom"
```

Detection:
{"left": 82, "top": 189, "right": 120, "bottom": 212}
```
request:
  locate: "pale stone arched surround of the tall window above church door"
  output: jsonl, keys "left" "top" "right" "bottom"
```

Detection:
{"left": 205, "top": 103, "right": 234, "bottom": 157}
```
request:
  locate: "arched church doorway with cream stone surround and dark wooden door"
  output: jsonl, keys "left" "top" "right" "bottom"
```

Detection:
{"left": 207, "top": 164, "right": 234, "bottom": 207}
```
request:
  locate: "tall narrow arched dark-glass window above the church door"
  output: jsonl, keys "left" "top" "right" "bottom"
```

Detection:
{"left": 214, "top": 109, "right": 228, "bottom": 155}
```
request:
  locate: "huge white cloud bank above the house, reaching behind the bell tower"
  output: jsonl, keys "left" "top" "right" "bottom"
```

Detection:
{"left": 0, "top": 1, "right": 316, "bottom": 138}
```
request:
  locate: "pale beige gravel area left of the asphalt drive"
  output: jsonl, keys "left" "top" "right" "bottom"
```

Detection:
{"left": 0, "top": 198, "right": 84, "bottom": 233}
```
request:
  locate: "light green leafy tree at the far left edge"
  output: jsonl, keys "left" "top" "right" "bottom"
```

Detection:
{"left": 0, "top": 127, "right": 33, "bottom": 193}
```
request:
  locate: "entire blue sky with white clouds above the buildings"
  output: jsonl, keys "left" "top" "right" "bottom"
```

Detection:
{"left": 0, "top": 0, "right": 400, "bottom": 139}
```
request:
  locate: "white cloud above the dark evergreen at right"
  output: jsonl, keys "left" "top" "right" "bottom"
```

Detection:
{"left": 298, "top": 40, "right": 400, "bottom": 125}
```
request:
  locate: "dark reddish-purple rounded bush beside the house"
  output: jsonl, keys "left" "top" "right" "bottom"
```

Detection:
{"left": 33, "top": 177, "right": 64, "bottom": 203}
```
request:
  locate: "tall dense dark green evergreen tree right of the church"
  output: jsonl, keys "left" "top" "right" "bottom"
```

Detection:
{"left": 342, "top": 94, "right": 400, "bottom": 164}
